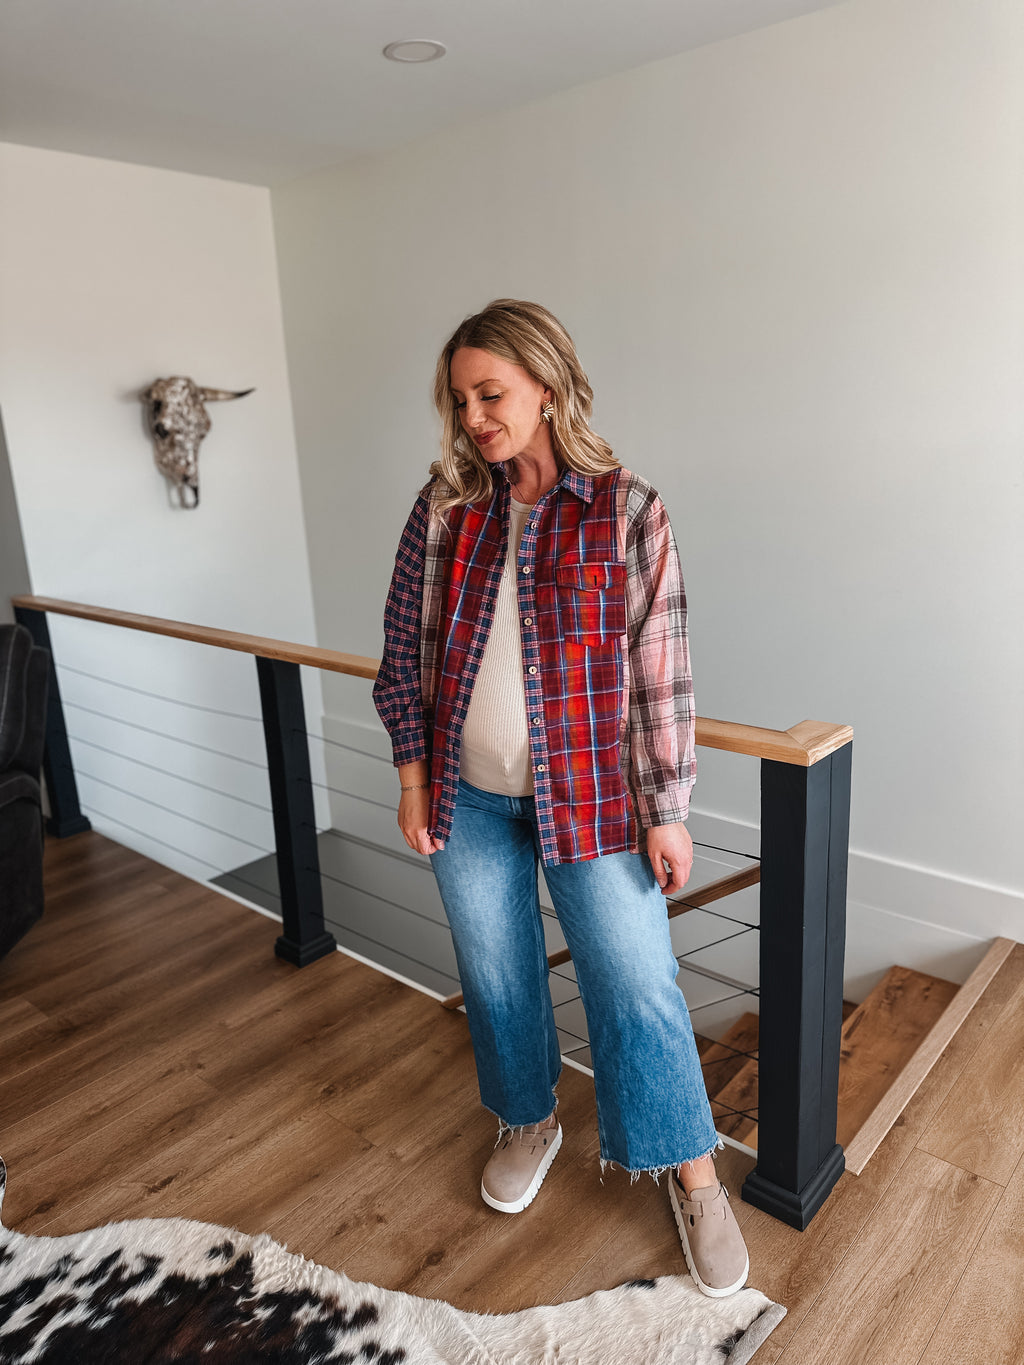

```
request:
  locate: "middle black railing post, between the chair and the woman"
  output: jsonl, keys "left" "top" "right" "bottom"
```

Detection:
{"left": 257, "top": 655, "right": 337, "bottom": 966}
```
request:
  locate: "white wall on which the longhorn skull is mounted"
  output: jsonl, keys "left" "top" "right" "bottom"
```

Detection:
{"left": 0, "top": 145, "right": 329, "bottom": 876}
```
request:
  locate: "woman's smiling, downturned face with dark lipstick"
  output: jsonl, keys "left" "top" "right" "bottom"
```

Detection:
{"left": 449, "top": 347, "right": 554, "bottom": 464}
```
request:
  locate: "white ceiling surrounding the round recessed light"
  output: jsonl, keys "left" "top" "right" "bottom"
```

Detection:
{"left": 0, "top": 0, "right": 840, "bottom": 184}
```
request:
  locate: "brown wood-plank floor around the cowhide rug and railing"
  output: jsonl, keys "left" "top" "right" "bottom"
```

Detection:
{"left": 0, "top": 834, "right": 1024, "bottom": 1365}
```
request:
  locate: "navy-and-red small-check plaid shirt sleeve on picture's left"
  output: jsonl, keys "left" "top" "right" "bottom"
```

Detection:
{"left": 373, "top": 494, "right": 430, "bottom": 767}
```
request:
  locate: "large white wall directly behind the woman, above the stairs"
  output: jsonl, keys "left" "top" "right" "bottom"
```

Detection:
{"left": 274, "top": 0, "right": 1024, "bottom": 992}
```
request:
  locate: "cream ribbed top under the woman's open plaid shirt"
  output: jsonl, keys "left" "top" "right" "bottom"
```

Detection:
{"left": 459, "top": 498, "right": 534, "bottom": 796}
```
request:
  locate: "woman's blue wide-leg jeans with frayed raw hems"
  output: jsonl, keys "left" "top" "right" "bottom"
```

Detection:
{"left": 430, "top": 781, "right": 718, "bottom": 1173}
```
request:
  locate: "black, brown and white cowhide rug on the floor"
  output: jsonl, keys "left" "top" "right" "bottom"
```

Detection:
{"left": 0, "top": 1162, "right": 785, "bottom": 1365}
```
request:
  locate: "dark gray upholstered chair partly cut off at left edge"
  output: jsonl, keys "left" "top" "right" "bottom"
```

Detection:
{"left": 0, "top": 625, "right": 49, "bottom": 957}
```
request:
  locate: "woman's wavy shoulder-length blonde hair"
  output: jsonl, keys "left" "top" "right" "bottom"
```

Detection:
{"left": 430, "top": 299, "right": 618, "bottom": 515}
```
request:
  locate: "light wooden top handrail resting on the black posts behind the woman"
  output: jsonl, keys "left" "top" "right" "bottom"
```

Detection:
{"left": 11, "top": 595, "right": 853, "bottom": 767}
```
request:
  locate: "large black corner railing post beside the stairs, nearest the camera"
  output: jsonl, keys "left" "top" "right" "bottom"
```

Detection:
{"left": 743, "top": 744, "right": 853, "bottom": 1229}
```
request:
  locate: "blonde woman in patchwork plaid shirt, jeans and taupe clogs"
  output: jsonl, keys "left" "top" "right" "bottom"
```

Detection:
{"left": 374, "top": 299, "right": 748, "bottom": 1297}
